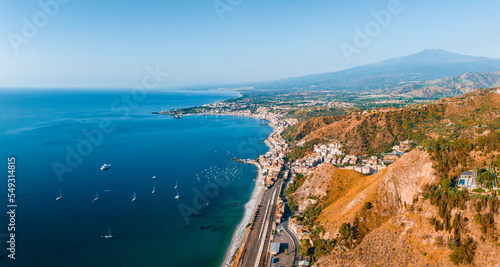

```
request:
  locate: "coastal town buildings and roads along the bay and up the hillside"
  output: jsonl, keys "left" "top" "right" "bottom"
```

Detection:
{"left": 157, "top": 95, "right": 499, "bottom": 267}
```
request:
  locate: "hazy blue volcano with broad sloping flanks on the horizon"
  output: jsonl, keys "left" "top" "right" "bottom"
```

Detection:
{"left": 253, "top": 49, "right": 500, "bottom": 93}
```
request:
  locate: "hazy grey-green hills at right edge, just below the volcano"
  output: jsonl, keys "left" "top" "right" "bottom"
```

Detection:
{"left": 392, "top": 72, "right": 500, "bottom": 98}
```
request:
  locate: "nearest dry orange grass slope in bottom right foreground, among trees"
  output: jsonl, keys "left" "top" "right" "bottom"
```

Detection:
{"left": 314, "top": 200, "right": 500, "bottom": 267}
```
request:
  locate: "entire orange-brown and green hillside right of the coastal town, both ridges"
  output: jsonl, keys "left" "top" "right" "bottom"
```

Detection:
{"left": 283, "top": 88, "right": 500, "bottom": 266}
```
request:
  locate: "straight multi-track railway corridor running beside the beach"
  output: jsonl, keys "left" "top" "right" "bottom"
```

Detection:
{"left": 237, "top": 180, "right": 282, "bottom": 267}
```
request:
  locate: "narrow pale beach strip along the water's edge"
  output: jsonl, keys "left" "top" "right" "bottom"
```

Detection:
{"left": 221, "top": 121, "right": 276, "bottom": 267}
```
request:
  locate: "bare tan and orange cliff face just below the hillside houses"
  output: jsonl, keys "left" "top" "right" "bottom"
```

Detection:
{"left": 319, "top": 149, "right": 436, "bottom": 238}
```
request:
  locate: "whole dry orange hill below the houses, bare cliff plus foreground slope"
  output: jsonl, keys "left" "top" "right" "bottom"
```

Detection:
{"left": 294, "top": 149, "right": 500, "bottom": 267}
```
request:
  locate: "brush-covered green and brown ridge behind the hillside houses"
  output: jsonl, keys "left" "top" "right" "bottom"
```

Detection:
{"left": 283, "top": 88, "right": 500, "bottom": 156}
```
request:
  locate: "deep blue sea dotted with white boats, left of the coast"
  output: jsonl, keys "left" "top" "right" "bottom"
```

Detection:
{"left": 0, "top": 89, "right": 272, "bottom": 267}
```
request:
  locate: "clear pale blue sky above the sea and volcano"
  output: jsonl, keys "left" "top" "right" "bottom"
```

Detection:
{"left": 0, "top": 0, "right": 500, "bottom": 88}
